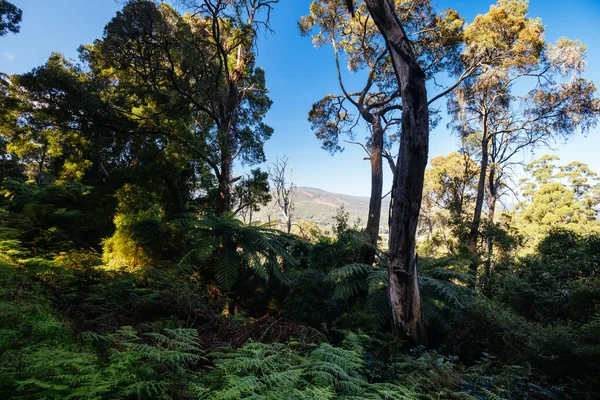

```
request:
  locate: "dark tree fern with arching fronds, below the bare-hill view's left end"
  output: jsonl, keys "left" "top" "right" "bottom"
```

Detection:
{"left": 177, "top": 214, "right": 298, "bottom": 291}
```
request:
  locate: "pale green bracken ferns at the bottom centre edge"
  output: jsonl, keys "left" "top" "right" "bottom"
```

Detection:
{"left": 195, "top": 334, "right": 417, "bottom": 400}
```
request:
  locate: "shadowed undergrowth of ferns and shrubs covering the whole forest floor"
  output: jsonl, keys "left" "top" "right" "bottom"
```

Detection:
{"left": 0, "top": 182, "right": 600, "bottom": 399}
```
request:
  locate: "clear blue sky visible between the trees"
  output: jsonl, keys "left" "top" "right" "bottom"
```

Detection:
{"left": 0, "top": 0, "right": 600, "bottom": 196}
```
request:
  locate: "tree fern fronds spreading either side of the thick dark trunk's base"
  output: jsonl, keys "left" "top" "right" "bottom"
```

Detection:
{"left": 327, "top": 253, "right": 476, "bottom": 326}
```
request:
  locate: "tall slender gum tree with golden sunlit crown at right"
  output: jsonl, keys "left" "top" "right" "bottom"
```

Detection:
{"left": 449, "top": 0, "right": 600, "bottom": 271}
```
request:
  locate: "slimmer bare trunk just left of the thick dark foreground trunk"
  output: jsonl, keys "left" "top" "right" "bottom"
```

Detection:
{"left": 360, "top": 116, "right": 384, "bottom": 264}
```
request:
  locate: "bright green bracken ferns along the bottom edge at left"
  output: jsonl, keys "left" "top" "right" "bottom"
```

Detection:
{"left": 8, "top": 327, "right": 204, "bottom": 399}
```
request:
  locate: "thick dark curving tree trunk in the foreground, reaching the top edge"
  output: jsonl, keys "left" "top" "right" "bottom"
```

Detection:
{"left": 366, "top": 0, "right": 429, "bottom": 344}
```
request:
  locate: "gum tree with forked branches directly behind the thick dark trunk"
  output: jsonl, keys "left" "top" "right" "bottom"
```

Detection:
{"left": 299, "top": 0, "right": 463, "bottom": 263}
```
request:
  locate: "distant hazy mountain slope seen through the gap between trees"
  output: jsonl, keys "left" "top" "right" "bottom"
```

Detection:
{"left": 253, "top": 187, "right": 389, "bottom": 234}
